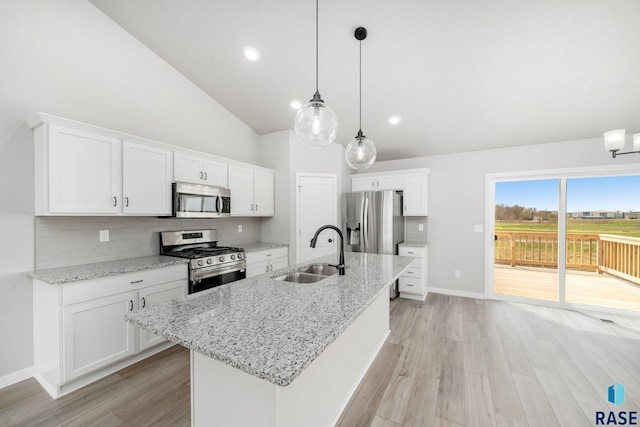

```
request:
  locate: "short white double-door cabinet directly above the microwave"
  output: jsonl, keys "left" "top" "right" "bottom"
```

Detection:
{"left": 173, "top": 152, "right": 228, "bottom": 188}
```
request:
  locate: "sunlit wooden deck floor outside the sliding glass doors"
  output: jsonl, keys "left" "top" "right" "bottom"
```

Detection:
{"left": 493, "top": 264, "right": 640, "bottom": 311}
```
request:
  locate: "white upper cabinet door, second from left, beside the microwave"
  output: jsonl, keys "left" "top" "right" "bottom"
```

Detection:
{"left": 122, "top": 141, "right": 173, "bottom": 215}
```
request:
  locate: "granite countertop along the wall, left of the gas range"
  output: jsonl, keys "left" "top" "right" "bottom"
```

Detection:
{"left": 27, "top": 255, "right": 189, "bottom": 285}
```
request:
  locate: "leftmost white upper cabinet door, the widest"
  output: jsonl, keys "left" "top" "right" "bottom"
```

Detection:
{"left": 48, "top": 125, "right": 122, "bottom": 214}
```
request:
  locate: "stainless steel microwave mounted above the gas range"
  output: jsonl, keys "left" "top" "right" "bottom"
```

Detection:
{"left": 172, "top": 182, "right": 231, "bottom": 218}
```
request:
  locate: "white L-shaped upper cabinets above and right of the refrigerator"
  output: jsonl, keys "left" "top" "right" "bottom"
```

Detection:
{"left": 351, "top": 168, "right": 429, "bottom": 216}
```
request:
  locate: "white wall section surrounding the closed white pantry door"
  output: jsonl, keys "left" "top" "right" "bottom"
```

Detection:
{"left": 260, "top": 130, "right": 351, "bottom": 263}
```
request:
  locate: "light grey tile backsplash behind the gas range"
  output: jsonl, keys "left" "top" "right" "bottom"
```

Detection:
{"left": 35, "top": 217, "right": 262, "bottom": 270}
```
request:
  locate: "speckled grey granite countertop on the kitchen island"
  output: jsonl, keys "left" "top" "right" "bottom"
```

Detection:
{"left": 125, "top": 253, "right": 414, "bottom": 386}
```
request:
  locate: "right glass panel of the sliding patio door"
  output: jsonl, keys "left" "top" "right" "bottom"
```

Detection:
{"left": 565, "top": 176, "right": 640, "bottom": 310}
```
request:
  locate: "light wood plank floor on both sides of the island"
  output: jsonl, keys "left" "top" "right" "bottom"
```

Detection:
{"left": 0, "top": 294, "right": 640, "bottom": 427}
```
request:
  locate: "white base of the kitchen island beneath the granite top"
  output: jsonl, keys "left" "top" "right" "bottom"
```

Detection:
{"left": 191, "top": 287, "right": 389, "bottom": 427}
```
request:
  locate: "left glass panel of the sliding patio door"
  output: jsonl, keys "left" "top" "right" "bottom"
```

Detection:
{"left": 493, "top": 179, "right": 559, "bottom": 301}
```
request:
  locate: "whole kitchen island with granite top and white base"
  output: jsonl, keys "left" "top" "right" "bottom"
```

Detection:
{"left": 126, "top": 253, "right": 413, "bottom": 426}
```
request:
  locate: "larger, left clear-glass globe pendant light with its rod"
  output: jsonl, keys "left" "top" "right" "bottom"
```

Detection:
{"left": 293, "top": 0, "right": 338, "bottom": 148}
